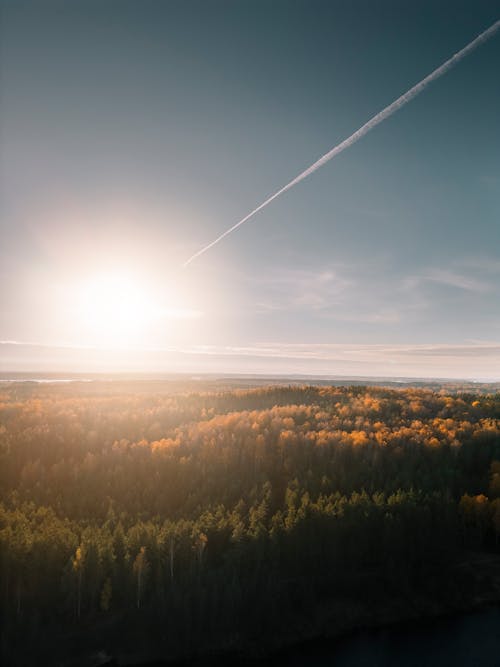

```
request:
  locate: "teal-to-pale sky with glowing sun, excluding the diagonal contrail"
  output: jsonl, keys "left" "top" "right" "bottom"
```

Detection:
{"left": 0, "top": 0, "right": 500, "bottom": 380}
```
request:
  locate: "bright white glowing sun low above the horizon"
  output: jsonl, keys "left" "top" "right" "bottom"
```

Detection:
{"left": 78, "top": 274, "right": 158, "bottom": 343}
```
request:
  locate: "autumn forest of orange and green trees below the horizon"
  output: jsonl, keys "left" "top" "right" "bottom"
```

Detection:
{"left": 0, "top": 382, "right": 500, "bottom": 665}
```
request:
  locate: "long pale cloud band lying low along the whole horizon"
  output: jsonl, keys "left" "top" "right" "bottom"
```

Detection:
{"left": 0, "top": 340, "right": 500, "bottom": 381}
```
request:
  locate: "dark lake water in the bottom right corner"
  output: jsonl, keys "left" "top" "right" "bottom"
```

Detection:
{"left": 278, "top": 607, "right": 500, "bottom": 667}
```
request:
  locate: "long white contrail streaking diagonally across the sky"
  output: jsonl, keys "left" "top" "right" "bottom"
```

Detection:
{"left": 182, "top": 20, "right": 500, "bottom": 267}
